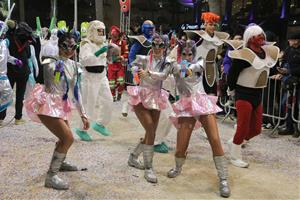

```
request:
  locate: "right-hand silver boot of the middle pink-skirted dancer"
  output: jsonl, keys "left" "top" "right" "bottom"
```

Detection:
{"left": 143, "top": 144, "right": 157, "bottom": 183}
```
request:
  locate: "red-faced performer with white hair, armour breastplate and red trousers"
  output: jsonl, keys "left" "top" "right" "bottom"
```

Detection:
{"left": 227, "top": 25, "right": 279, "bottom": 167}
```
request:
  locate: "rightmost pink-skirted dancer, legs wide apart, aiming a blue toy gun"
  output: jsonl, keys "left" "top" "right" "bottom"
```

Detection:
{"left": 168, "top": 40, "right": 230, "bottom": 197}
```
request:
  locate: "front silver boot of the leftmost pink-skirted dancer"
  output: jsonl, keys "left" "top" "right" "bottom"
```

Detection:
{"left": 45, "top": 150, "right": 69, "bottom": 190}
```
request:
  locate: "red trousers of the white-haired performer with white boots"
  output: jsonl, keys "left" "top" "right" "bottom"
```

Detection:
{"left": 233, "top": 100, "right": 263, "bottom": 145}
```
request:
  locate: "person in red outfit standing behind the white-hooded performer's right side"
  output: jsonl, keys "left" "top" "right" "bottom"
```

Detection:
{"left": 108, "top": 26, "right": 128, "bottom": 101}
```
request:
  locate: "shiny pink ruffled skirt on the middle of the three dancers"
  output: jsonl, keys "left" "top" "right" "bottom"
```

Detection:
{"left": 127, "top": 86, "right": 169, "bottom": 110}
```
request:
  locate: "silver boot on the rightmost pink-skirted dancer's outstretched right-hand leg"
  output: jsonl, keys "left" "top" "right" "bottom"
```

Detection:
{"left": 214, "top": 156, "right": 230, "bottom": 197}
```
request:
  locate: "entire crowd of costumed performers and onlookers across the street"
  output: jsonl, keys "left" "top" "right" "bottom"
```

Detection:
{"left": 0, "top": 12, "right": 300, "bottom": 197}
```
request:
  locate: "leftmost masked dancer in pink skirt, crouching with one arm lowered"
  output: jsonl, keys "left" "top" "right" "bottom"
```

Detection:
{"left": 24, "top": 31, "right": 89, "bottom": 190}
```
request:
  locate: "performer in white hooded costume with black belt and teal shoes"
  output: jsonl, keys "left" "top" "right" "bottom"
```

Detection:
{"left": 75, "top": 20, "right": 113, "bottom": 141}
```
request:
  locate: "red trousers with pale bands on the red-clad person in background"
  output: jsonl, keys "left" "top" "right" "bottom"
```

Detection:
{"left": 108, "top": 63, "right": 125, "bottom": 96}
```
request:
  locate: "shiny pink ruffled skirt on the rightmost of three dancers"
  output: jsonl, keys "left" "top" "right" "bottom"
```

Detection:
{"left": 170, "top": 92, "right": 222, "bottom": 129}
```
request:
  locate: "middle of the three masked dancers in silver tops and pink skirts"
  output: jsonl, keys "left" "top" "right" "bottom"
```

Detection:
{"left": 127, "top": 34, "right": 176, "bottom": 183}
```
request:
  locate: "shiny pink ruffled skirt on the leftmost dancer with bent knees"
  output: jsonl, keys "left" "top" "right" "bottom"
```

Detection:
{"left": 24, "top": 84, "right": 72, "bottom": 122}
